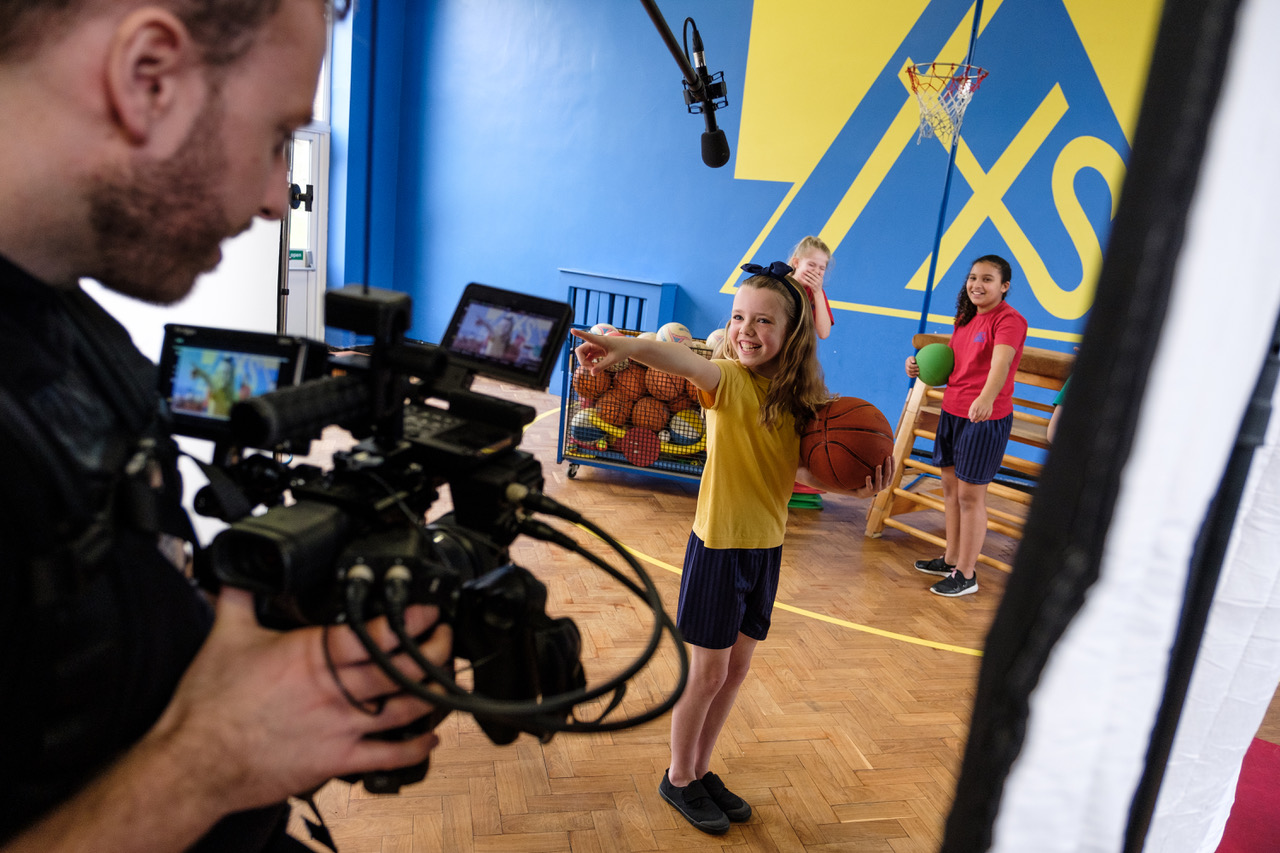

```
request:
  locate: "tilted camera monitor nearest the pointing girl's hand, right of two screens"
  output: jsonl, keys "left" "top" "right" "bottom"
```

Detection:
{"left": 440, "top": 283, "right": 572, "bottom": 389}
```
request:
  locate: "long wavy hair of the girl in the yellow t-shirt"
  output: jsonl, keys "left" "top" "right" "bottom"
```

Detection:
{"left": 724, "top": 275, "right": 831, "bottom": 433}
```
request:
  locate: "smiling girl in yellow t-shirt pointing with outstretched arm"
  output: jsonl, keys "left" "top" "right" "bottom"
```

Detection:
{"left": 573, "top": 263, "right": 893, "bottom": 835}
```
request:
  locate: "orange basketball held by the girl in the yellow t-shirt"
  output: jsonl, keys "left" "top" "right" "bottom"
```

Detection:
{"left": 800, "top": 397, "right": 893, "bottom": 489}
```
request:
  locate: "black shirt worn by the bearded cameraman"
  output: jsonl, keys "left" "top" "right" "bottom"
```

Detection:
{"left": 0, "top": 256, "right": 293, "bottom": 853}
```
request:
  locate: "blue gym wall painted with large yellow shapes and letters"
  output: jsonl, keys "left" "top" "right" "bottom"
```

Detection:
{"left": 330, "top": 0, "right": 1158, "bottom": 420}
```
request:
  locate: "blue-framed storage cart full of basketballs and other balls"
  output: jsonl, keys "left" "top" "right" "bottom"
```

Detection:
{"left": 556, "top": 327, "right": 712, "bottom": 479}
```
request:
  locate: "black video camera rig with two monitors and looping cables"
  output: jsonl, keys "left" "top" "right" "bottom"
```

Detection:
{"left": 160, "top": 283, "right": 687, "bottom": 793}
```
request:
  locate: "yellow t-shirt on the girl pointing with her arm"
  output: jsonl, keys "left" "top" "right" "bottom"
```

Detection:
{"left": 694, "top": 359, "right": 800, "bottom": 548}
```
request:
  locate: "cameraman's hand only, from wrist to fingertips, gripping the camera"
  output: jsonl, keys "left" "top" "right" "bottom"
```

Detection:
{"left": 148, "top": 589, "right": 452, "bottom": 812}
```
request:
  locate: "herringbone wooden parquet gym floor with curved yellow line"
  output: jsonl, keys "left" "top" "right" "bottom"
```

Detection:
{"left": 285, "top": 380, "right": 1274, "bottom": 853}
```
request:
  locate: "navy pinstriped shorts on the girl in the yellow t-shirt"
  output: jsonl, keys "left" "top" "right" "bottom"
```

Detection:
{"left": 676, "top": 533, "right": 782, "bottom": 648}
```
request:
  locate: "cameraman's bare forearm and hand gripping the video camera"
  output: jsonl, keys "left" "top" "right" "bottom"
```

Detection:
{"left": 4, "top": 589, "right": 453, "bottom": 853}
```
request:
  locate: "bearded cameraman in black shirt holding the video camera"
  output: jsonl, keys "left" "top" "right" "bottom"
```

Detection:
{"left": 0, "top": 0, "right": 451, "bottom": 853}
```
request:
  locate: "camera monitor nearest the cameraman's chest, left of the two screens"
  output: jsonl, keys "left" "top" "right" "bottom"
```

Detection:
{"left": 160, "top": 324, "right": 323, "bottom": 441}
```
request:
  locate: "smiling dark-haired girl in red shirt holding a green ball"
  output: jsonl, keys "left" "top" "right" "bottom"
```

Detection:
{"left": 906, "top": 255, "right": 1027, "bottom": 598}
